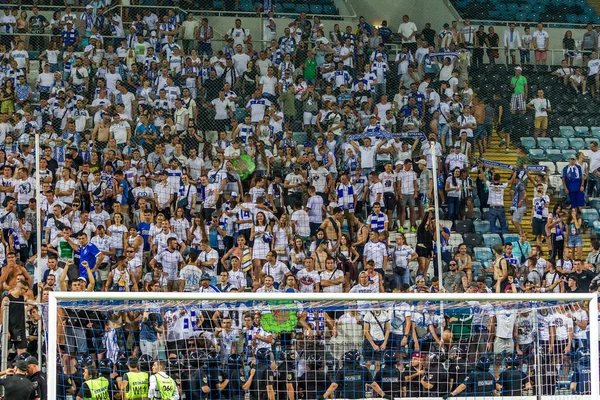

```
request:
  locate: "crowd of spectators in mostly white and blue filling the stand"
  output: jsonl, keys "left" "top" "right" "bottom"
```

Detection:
{"left": 0, "top": 1, "right": 600, "bottom": 399}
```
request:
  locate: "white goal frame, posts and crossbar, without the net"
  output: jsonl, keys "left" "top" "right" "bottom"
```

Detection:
{"left": 46, "top": 292, "right": 600, "bottom": 399}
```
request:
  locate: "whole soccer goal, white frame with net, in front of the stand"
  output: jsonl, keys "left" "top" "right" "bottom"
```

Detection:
{"left": 47, "top": 292, "right": 599, "bottom": 400}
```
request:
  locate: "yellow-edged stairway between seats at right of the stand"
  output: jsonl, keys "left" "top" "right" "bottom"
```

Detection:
{"left": 471, "top": 137, "right": 600, "bottom": 260}
